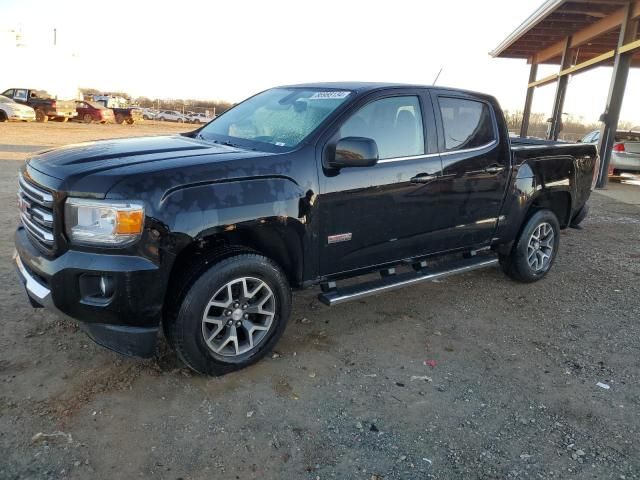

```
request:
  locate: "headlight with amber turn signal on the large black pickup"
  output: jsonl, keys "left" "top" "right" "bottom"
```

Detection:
{"left": 64, "top": 198, "right": 144, "bottom": 246}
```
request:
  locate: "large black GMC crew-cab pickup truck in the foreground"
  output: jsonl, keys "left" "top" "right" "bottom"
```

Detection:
{"left": 15, "top": 83, "right": 598, "bottom": 374}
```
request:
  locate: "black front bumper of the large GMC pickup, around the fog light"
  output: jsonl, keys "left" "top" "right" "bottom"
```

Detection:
{"left": 14, "top": 227, "right": 164, "bottom": 357}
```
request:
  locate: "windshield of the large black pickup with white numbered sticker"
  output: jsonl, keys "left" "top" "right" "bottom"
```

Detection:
{"left": 199, "top": 88, "right": 351, "bottom": 148}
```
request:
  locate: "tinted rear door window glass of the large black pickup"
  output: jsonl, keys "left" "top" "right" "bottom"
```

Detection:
{"left": 438, "top": 97, "right": 496, "bottom": 151}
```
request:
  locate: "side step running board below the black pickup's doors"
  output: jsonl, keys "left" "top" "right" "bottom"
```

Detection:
{"left": 318, "top": 256, "right": 498, "bottom": 306}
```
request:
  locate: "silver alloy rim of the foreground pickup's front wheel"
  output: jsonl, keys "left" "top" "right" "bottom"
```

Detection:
{"left": 202, "top": 277, "right": 276, "bottom": 357}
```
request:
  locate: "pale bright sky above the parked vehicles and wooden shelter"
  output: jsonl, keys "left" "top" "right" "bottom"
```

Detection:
{"left": 0, "top": 0, "right": 640, "bottom": 125}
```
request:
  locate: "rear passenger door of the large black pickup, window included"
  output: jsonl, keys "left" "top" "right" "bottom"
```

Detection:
{"left": 432, "top": 90, "right": 511, "bottom": 251}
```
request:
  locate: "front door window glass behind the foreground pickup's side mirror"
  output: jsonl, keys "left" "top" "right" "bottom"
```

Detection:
{"left": 339, "top": 96, "right": 424, "bottom": 160}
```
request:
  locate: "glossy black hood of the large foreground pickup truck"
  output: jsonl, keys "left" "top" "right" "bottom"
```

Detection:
{"left": 28, "top": 135, "right": 265, "bottom": 181}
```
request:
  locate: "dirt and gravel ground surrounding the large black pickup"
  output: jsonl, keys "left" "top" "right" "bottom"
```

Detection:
{"left": 0, "top": 123, "right": 640, "bottom": 480}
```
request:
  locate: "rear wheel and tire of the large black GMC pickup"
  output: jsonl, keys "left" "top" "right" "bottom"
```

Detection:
{"left": 500, "top": 210, "right": 560, "bottom": 283}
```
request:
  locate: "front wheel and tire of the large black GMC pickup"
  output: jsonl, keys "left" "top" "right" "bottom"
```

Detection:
{"left": 163, "top": 251, "right": 291, "bottom": 375}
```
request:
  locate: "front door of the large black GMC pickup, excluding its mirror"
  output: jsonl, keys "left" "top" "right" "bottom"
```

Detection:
{"left": 318, "top": 90, "right": 441, "bottom": 275}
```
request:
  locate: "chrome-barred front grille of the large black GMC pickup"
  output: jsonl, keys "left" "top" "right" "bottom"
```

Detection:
{"left": 18, "top": 175, "right": 56, "bottom": 252}
